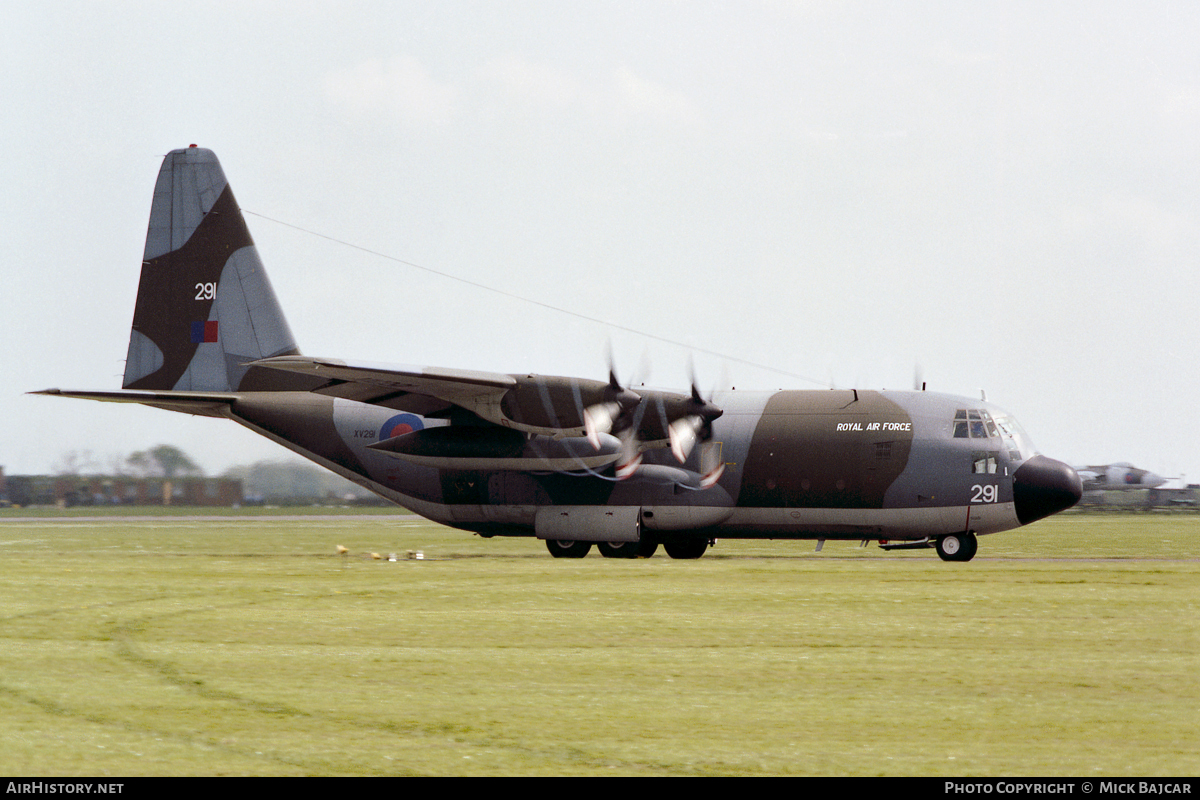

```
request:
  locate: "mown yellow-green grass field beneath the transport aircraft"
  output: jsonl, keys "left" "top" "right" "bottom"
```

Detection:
{"left": 0, "top": 513, "right": 1200, "bottom": 776}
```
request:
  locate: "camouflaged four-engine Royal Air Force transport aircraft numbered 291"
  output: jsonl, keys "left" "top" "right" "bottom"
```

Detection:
{"left": 42, "top": 145, "right": 1081, "bottom": 561}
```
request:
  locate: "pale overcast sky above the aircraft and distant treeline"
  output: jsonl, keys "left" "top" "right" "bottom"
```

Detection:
{"left": 0, "top": 0, "right": 1200, "bottom": 481}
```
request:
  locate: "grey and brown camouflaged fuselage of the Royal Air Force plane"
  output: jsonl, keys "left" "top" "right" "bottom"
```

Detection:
{"left": 229, "top": 383, "right": 1034, "bottom": 539}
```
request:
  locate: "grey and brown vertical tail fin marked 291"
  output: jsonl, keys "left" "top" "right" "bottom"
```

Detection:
{"left": 122, "top": 145, "right": 299, "bottom": 391}
